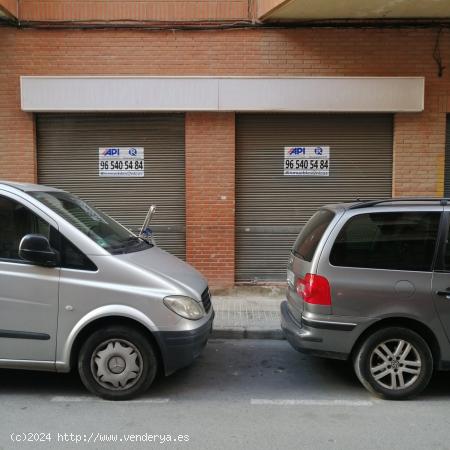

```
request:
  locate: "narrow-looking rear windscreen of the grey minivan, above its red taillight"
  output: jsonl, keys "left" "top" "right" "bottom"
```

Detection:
{"left": 292, "top": 209, "right": 334, "bottom": 262}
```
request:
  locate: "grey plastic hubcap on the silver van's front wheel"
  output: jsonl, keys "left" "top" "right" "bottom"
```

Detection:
{"left": 91, "top": 339, "right": 143, "bottom": 390}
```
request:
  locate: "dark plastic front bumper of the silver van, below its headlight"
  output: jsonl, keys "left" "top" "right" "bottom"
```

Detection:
{"left": 156, "top": 310, "right": 214, "bottom": 375}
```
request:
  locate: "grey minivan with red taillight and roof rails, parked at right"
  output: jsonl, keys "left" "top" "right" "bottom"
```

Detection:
{"left": 281, "top": 198, "right": 450, "bottom": 399}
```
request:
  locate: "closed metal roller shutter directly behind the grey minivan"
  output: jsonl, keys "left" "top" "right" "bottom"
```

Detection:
{"left": 236, "top": 114, "right": 393, "bottom": 281}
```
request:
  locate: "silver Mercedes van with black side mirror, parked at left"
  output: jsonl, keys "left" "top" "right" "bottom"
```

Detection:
{"left": 0, "top": 182, "right": 214, "bottom": 400}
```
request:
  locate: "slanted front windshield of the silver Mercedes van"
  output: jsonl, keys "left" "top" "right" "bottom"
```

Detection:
{"left": 28, "top": 191, "right": 152, "bottom": 254}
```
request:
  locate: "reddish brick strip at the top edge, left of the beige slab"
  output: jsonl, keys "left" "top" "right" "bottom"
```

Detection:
{"left": 20, "top": 0, "right": 248, "bottom": 21}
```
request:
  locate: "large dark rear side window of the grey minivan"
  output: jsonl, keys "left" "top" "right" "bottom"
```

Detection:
{"left": 330, "top": 211, "right": 441, "bottom": 272}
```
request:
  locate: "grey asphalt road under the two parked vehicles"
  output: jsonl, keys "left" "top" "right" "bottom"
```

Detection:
{"left": 0, "top": 340, "right": 450, "bottom": 450}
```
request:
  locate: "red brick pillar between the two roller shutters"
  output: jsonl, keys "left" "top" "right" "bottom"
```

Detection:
{"left": 186, "top": 113, "right": 235, "bottom": 287}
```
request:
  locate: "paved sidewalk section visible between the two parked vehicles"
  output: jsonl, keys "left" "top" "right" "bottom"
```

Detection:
{"left": 212, "top": 286, "right": 285, "bottom": 339}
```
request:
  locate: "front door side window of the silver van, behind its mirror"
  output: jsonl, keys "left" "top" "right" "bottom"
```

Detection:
{"left": 0, "top": 196, "right": 50, "bottom": 262}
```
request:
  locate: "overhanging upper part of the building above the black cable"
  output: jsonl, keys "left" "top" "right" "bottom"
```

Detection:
{"left": 0, "top": 0, "right": 450, "bottom": 27}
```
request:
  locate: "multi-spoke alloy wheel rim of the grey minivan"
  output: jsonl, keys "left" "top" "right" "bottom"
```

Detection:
{"left": 370, "top": 339, "right": 422, "bottom": 390}
